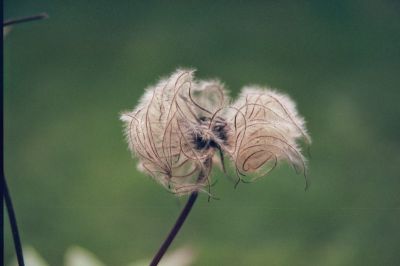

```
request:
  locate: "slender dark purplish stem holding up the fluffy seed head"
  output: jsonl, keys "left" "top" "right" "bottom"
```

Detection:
{"left": 150, "top": 191, "right": 198, "bottom": 266}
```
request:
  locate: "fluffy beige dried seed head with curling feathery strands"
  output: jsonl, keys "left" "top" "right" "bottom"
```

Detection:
{"left": 121, "top": 69, "right": 311, "bottom": 195}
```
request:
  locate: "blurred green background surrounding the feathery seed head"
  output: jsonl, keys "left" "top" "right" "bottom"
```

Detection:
{"left": 4, "top": 0, "right": 400, "bottom": 265}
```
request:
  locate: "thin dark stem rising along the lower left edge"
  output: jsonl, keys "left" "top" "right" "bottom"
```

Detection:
{"left": 3, "top": 175, "right": 25, "bottom": 266}
